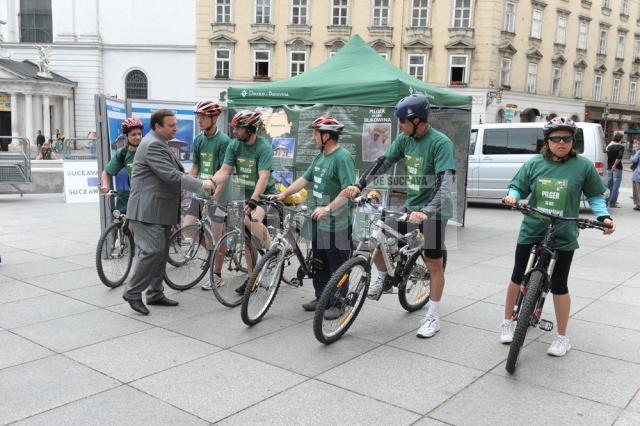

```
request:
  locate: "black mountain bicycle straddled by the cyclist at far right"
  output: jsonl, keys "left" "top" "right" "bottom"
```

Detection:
{"left": 505, "top": 204, "right": 611, "bottom": 374}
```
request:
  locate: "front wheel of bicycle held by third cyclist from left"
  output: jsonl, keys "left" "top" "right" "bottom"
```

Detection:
{"left": 209, "top": 230, "right": 247, "bottom": 308}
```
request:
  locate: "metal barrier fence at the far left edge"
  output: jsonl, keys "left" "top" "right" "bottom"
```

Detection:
{"left": 0, "top": 136, "right": 31, "bottom": 197}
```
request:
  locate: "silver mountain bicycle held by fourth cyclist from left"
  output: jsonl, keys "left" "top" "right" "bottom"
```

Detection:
{"left": 240, "top": 196, "right": 317, "bottom": 326}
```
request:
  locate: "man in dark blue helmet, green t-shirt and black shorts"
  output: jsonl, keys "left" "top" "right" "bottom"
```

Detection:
{"left": 344, "top": 94, "right": 456, "bottom": 337}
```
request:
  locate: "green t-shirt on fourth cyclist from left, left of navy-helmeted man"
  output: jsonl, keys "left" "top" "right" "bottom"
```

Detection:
{"left": 302, "top": 147, "right": 356, "bottom": 232}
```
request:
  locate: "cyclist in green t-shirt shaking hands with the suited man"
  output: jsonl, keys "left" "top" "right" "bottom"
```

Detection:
{"left": 213, "top": 110, "right": 275, "bottom": 292}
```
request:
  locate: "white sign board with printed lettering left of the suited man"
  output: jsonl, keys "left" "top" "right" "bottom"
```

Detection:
{"left": 63, "top": 160, "right": 100, "bottom": 203}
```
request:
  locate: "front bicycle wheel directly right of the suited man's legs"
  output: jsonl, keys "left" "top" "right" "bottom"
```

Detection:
{"left": 164, "top": 225, "right": 213, "bottom": 290}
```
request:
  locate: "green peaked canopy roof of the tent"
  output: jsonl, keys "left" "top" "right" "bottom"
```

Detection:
{"left": 228, "top": 35, "right": 471, "bottom": 109}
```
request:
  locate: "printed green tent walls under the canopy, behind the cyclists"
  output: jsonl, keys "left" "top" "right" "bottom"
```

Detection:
{"left": 229, "top": 104, "right": 471, "bottom": 223}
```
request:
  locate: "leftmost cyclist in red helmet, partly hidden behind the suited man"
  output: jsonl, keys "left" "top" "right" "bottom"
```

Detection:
{"left": 100, "top": 118, "right": 143, "bottom": 213}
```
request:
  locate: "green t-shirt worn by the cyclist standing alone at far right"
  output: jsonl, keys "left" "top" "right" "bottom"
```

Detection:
{"left": 509, "top": 154, "right": 606, "bottom": 250}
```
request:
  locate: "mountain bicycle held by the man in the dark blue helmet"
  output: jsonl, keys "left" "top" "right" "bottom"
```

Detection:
{"left": 313, "top": 196, "right": 447, "bottom": 344}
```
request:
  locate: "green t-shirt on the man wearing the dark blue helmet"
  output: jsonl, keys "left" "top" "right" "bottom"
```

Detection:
{"left": 384, "top": 127, "right": 456, "bottom": 219}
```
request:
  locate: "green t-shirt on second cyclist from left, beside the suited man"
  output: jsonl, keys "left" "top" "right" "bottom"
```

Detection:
{"left": 192, "top": 129, "right": 231, "bottom": 202}
